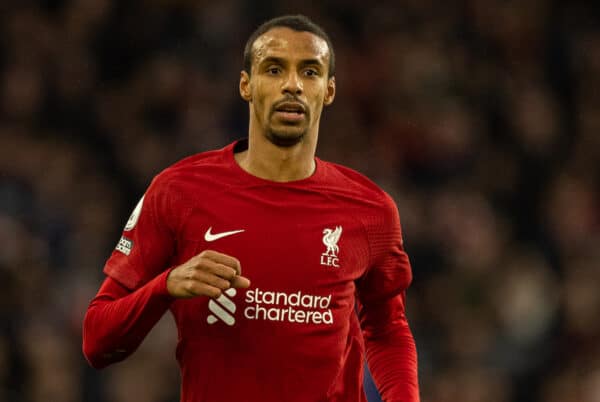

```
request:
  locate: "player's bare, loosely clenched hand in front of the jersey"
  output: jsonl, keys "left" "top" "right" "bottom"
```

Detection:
{"left": 167, "top": 250, "right": 250, "bottom": 299}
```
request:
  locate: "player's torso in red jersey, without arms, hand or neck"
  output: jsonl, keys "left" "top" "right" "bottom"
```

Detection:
{"left": 118, "top": 140, "right": 394, "bottom": 402}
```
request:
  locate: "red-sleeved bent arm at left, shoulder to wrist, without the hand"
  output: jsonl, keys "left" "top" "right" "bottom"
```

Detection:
{"left": 83, "top": 178, "right": 177, "bottom": 368}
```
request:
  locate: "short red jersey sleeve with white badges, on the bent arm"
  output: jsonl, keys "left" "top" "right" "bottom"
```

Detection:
{"left": 104, "top": 175, "right": 177, "bottom": 289}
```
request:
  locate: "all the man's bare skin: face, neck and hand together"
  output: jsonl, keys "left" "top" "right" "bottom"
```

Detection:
{"left": 167, "top": 27, "right": 335, "bottom": 298}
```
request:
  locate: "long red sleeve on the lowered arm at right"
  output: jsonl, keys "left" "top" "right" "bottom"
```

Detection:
{"left": 357, "top": 195, "right": 419, "bottom": 402}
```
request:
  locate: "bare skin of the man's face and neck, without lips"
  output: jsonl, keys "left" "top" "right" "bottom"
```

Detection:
{"left": 235, "top": 27, "right": 335, "bottom": 182}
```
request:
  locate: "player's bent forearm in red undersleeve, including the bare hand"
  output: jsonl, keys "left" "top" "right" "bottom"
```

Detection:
{"left": 83, "top": 250, "right": 250, "bottom": 368}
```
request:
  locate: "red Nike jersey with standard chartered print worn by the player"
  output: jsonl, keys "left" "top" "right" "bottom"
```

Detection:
{"left": 97, "top": 141, "right": 418, "bottom": 402}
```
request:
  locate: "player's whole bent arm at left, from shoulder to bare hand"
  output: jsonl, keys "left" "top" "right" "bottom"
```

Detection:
{"left": 83, "top": 176, "right": 250, "bottom": 368}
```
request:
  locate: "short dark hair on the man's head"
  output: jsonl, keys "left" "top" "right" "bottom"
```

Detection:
{"left": 244, "top": 14, "right": 335, "bottom": 77}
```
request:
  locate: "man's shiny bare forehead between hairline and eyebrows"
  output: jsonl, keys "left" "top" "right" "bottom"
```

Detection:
{"left": 252, "top": 27, "right": 329, "bottom": 65}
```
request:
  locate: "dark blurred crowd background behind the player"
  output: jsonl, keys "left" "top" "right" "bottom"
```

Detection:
{"left": 0, "top": 0, "right": 600, "bottom": 402}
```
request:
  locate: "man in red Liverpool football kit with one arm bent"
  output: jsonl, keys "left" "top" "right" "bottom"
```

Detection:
{"left": 83, "top": 16, "right": 419, "bottom": 402}
